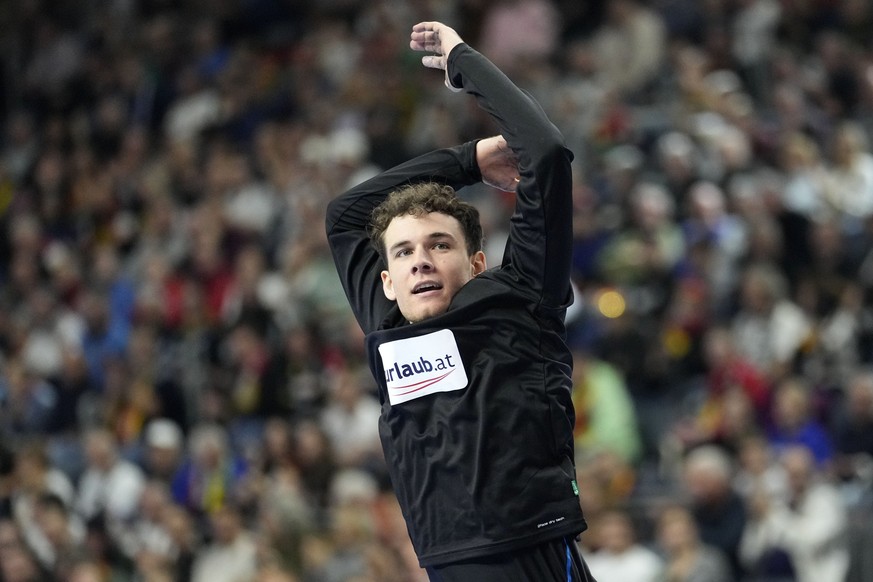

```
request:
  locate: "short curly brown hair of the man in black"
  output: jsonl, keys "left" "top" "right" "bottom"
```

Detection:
{"left": 369, "top": 182, "right": 484, "bottom": 264}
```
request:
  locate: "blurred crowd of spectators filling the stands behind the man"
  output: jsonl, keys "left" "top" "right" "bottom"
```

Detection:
{"left": 0, "top": 0, "right": 873, "bottom": 582}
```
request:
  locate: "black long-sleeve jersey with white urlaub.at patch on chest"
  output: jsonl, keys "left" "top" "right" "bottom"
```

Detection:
{"left": 327, "top": 44, "right": 586, "bottom": 566}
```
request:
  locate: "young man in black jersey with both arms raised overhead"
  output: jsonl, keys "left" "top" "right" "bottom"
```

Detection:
{"left": 327, "top": 22, "right": 591, "bottom": 582}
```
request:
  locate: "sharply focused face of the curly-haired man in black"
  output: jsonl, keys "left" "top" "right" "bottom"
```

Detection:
{"left": 382, "top": 212, "right": 485, "bottom": 323}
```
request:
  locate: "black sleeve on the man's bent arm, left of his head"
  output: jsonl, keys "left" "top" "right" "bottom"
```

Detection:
{"left": 326, "top": 142, "right": 481, "bottom": 333}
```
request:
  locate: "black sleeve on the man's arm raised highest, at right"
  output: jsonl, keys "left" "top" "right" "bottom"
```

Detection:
{"left": 448, "top": 44, "right": 573, "bottom": 308}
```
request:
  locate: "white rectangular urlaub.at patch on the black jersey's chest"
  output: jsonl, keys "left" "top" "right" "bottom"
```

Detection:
{"left": 379, "top": 329, "right": 467, "bottom": 406}
